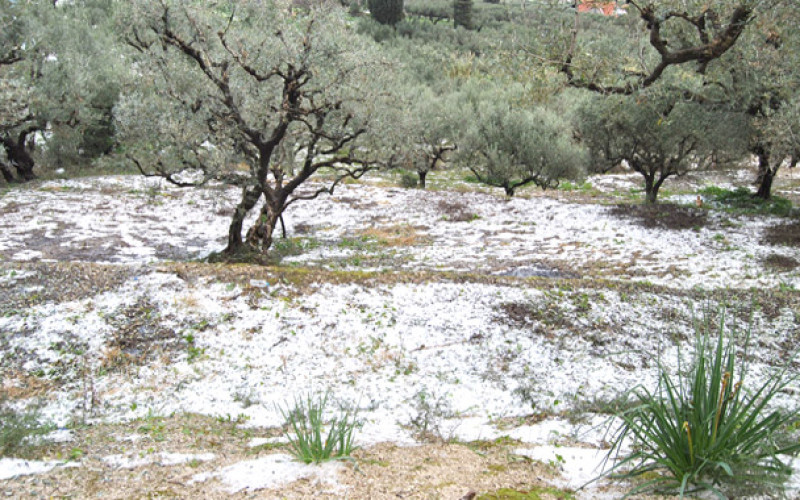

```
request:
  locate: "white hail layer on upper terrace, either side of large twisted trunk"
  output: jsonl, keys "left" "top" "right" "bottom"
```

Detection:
{"left": 0, "top": 176, "right": 800, "bottom": 289}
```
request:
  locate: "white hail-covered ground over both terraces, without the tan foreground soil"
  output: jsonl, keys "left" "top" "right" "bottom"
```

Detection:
{"left": 0, "top": 177, "right": 800, "bottom": 498}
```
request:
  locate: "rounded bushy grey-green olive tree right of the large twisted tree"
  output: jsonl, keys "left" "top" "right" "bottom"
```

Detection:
{"left": 457, "top": 85, "right": 586, "bottom": 196}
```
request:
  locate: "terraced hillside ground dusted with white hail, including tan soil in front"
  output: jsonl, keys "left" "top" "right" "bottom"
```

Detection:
{"left": 0, "top": 166, "right": 800, "bottom": 498}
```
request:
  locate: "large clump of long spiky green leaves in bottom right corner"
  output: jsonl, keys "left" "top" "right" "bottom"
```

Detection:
{"left": 607, "top": 310, "right": 800, "bottom": 498}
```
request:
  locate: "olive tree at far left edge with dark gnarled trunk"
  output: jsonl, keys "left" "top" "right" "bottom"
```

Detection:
{"left": 0, "top": 0, "right": 123, "bottom": 182}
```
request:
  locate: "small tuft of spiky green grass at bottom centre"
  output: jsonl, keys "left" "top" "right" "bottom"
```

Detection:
{"left": 280, "top": 393, "right": 359, "bottom": 464}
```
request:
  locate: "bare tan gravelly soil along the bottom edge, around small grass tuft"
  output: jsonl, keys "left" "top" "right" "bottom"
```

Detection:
{"left": 0, "top": 414, "right": 570, "bottom": 500}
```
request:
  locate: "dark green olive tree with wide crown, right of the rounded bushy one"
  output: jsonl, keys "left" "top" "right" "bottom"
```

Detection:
{"left": 576, "top": 91, "right": 748, "bottom": 203}
